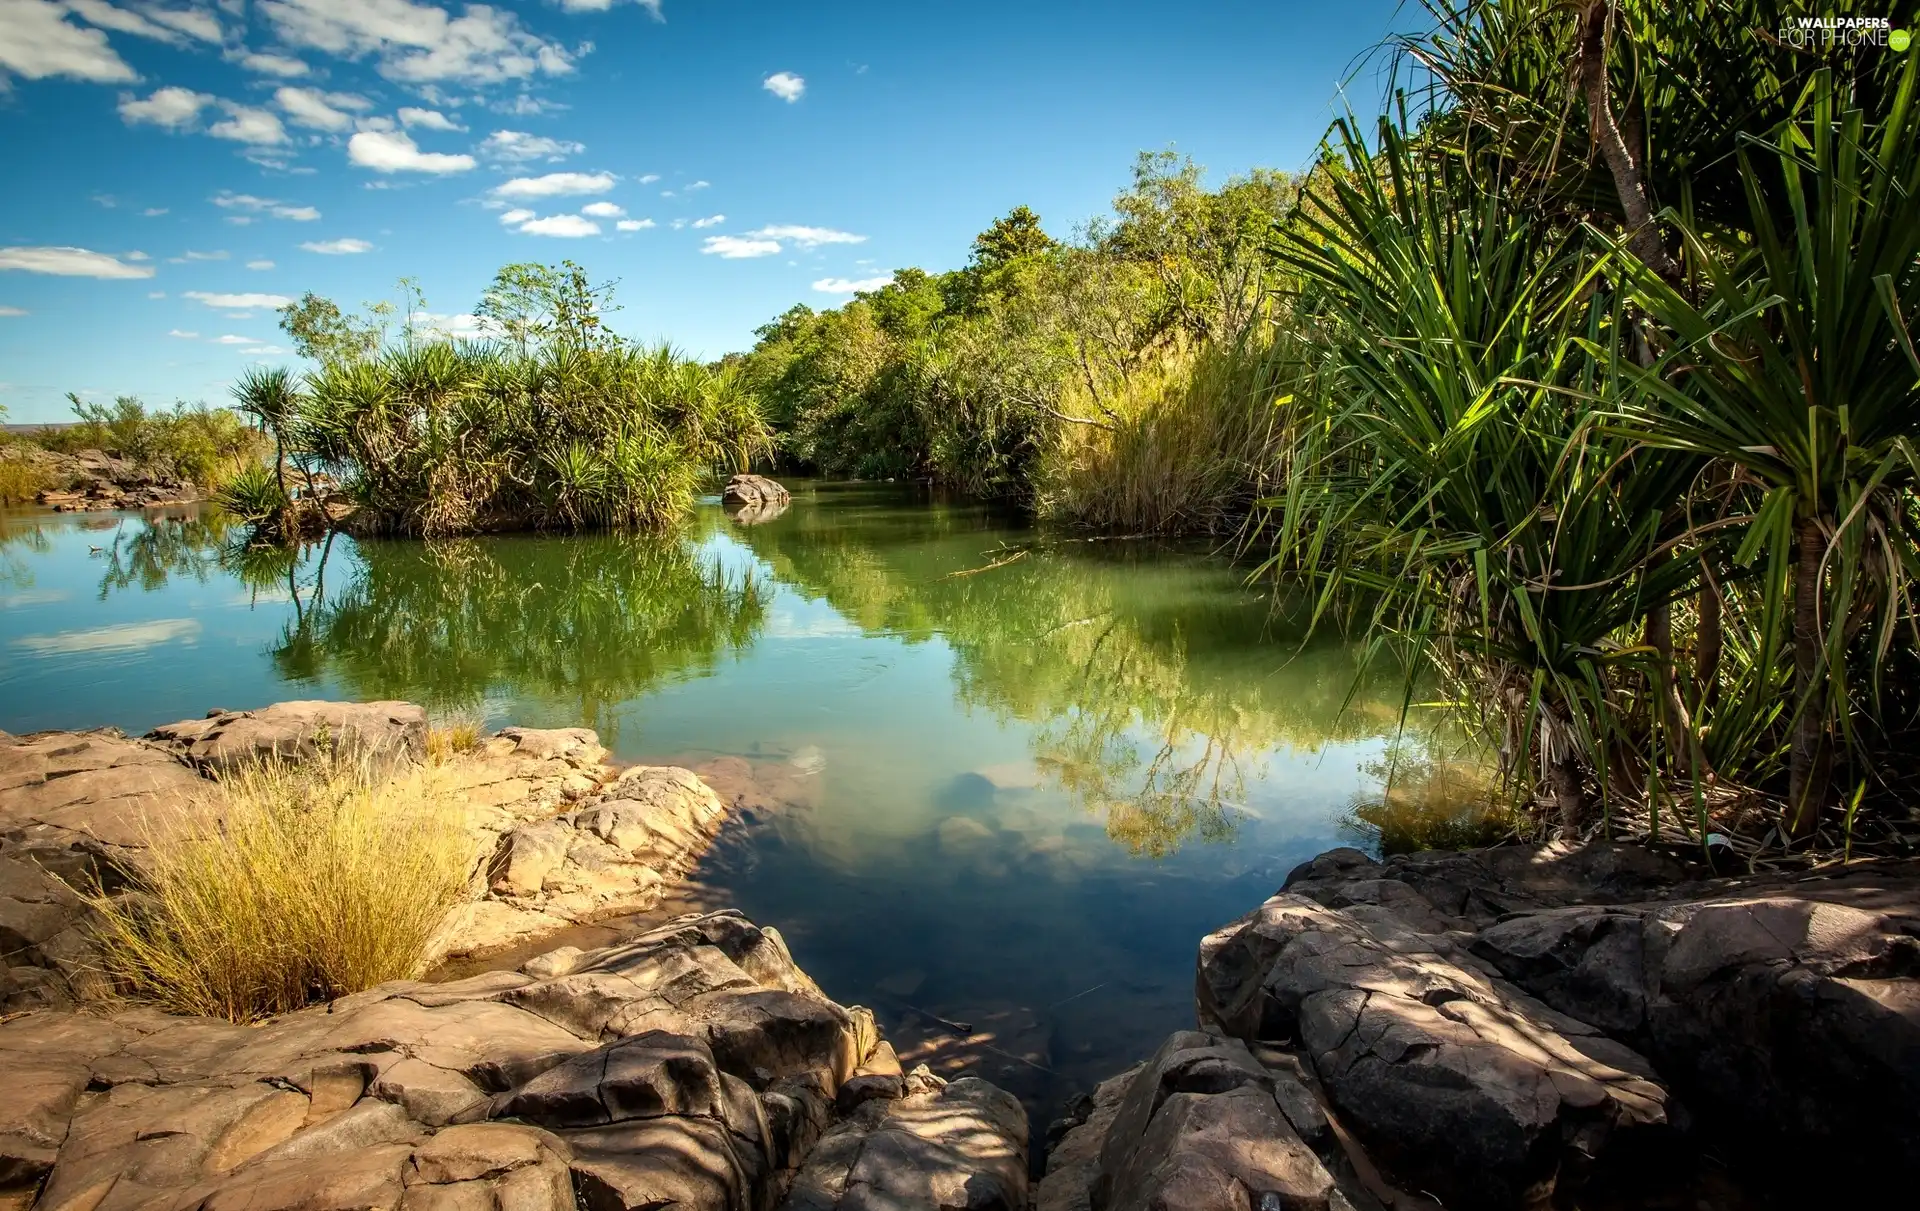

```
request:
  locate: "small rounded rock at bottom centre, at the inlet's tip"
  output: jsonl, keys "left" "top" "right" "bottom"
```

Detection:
{"left": 781, "top": 1077, "right": 1027, "bottom": 1211}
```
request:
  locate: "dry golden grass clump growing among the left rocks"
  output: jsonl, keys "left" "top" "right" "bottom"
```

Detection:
{"left": 94, "top": 756, "right": 472, "bottom": 1021}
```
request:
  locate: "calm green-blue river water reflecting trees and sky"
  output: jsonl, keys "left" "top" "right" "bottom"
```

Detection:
{"left": 0, "top": 484, "right": 1443, "bottom": 1111}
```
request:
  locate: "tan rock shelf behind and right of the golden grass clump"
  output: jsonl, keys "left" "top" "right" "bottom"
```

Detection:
{"left": 0, "top": 700, "right": 741, "bottom": 1011}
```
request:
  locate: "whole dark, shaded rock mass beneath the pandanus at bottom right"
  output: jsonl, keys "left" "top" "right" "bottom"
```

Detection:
{"left": 1037, "top": 844, "right": 1920, "bottom": 1211}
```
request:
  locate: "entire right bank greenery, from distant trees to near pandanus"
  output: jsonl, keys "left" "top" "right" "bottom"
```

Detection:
{"left": 743, "top": 0, "right": 1920, "bottom": 852}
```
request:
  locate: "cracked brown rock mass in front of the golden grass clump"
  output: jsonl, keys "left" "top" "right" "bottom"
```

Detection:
{"left": 0, "top": 912, "right": 1027, "bottom": 1211}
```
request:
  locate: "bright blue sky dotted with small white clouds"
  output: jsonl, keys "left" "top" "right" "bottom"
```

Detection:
{"left": 0, "top": 0, "right": 1409, "bottom": 422}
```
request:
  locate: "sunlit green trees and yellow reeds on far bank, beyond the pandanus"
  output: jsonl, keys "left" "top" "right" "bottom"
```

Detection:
{"left": 743, "top": 152, "right": 1294, "bottom": 530}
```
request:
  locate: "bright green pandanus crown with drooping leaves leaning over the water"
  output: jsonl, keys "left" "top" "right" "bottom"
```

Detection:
{"left": 1267, "top": 123, "right": 1693, "bottom": 825}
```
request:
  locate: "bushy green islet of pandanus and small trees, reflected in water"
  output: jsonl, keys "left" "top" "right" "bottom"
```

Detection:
{"left": 223, "top": 265, "right": 766, "bottom": 537}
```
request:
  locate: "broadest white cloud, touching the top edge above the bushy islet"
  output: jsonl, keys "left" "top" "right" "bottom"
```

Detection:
{"left": 257, "top": 0, "right": 588, "bottom": 84}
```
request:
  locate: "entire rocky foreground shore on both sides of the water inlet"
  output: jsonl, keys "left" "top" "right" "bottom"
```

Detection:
{"left": 11, "top": 702, "right": 1920, "bottom": 1211}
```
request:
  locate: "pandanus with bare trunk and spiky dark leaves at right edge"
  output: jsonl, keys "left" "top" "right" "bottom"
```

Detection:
{"left": 1617, "top": 59, "right": 1920, "bottom": 835}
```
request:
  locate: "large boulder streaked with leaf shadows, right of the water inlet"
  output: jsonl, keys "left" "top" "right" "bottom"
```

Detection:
{"left": 1196, "top": 892, "right": 1668, "bottom": 1207}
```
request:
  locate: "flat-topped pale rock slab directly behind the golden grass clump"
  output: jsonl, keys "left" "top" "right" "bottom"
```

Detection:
{"left": 146, "top": 700, "right": 426, "bottom": 773}
